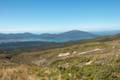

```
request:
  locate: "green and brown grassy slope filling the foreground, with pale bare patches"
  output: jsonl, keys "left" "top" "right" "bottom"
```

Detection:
{"left": 0, "top": 37, "right": 120, "bottom": 80}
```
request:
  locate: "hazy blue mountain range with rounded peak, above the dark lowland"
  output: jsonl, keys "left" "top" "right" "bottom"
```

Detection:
{"left": 0, "top": 30, "right": 97, "bottom": 42}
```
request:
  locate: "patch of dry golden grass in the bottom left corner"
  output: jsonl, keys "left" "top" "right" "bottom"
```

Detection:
{"left": 0, "top": 65, "right": 37, "bottom": 80}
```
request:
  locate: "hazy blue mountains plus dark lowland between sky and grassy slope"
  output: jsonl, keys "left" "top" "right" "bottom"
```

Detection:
{"left": 0, "top": 30, "right": 120, "bottom": 53}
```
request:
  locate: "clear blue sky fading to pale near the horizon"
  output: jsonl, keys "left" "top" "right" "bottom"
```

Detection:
{"left": 0, "top": 0, "right": 120, "bottom": 33}
